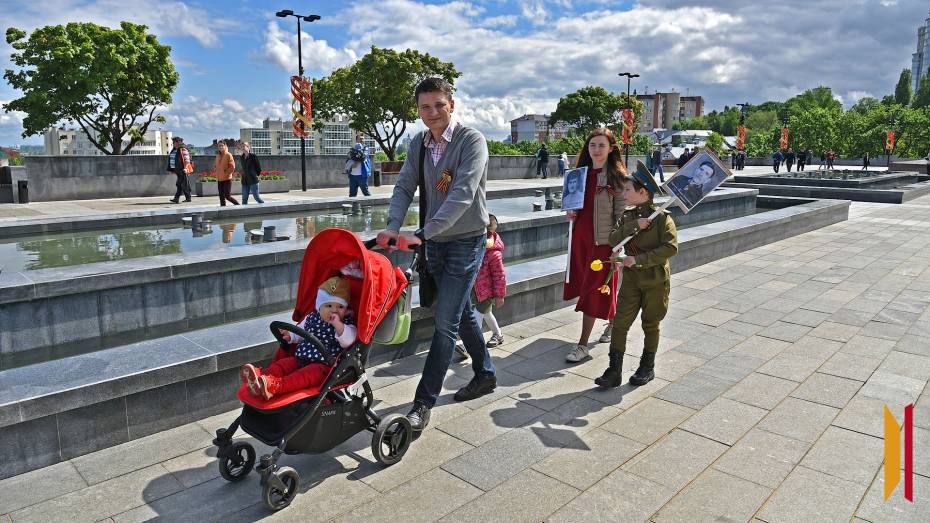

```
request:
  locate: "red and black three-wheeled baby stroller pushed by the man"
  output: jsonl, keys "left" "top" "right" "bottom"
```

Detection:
{"left": 213, "top": 229, "right": 417, "bottom": 510}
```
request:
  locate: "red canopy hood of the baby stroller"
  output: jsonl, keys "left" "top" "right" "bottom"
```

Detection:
{"left": 292, "top": 228, "right": 407, "bottom": 343}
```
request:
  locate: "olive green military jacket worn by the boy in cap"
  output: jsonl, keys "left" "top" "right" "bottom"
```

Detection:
{"left": 610, "top": 202, "right": 678, "bottom": 287}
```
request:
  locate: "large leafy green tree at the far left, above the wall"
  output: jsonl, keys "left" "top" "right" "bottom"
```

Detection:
{"left": 3, "top": 22, "right": 178, "bottom": 155}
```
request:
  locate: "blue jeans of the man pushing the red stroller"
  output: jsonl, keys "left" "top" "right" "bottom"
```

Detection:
{"left": 414, "top": 234, "right": 495, "bottom": 408}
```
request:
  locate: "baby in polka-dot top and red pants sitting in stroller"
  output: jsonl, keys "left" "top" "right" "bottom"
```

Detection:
{"left": 240, "top": 272, "right": 358, "bottom": 400}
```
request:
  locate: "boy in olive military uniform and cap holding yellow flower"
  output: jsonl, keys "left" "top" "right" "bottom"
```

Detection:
{"left": 594, "top": 162, "right": 678, "bottom": 387}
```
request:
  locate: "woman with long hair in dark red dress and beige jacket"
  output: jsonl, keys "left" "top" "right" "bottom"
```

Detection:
{"left": 562, "top": 128, "right": 626, "bottom": 363}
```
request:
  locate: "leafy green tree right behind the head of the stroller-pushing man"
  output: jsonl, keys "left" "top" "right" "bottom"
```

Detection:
{"left": 313, "top": 46, "right": 461, "bottom": 161}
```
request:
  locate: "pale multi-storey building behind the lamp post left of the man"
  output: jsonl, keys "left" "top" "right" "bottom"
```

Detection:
{"left": 239, "top": 116, "right": 380, "bottom": 156}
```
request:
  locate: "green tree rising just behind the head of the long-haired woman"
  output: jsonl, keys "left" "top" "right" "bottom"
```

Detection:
{"left": 549, "top": 86, "right": 624, "bottom": 136}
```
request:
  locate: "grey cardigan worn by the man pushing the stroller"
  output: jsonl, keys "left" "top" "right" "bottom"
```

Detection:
{"left": 387, "top": 125, "right": 488, "bottom": 242}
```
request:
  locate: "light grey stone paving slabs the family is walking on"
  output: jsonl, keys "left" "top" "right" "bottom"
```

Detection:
{"left": 0, "top": 174, "right": 930, "bottom": 523}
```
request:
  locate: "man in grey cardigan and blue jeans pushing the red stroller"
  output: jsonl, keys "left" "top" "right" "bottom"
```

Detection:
{"left": 377, "top": 78, "right": 497, "bottom": 431}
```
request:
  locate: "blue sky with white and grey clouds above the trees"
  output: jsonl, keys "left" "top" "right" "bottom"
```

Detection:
{"left": 0, "top": 0, "right": 930, "bottom": 145}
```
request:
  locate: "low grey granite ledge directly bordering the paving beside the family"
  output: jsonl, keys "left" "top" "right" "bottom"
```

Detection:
{"left": 0, "top": 195, "right": 849, "bottom": 479}
